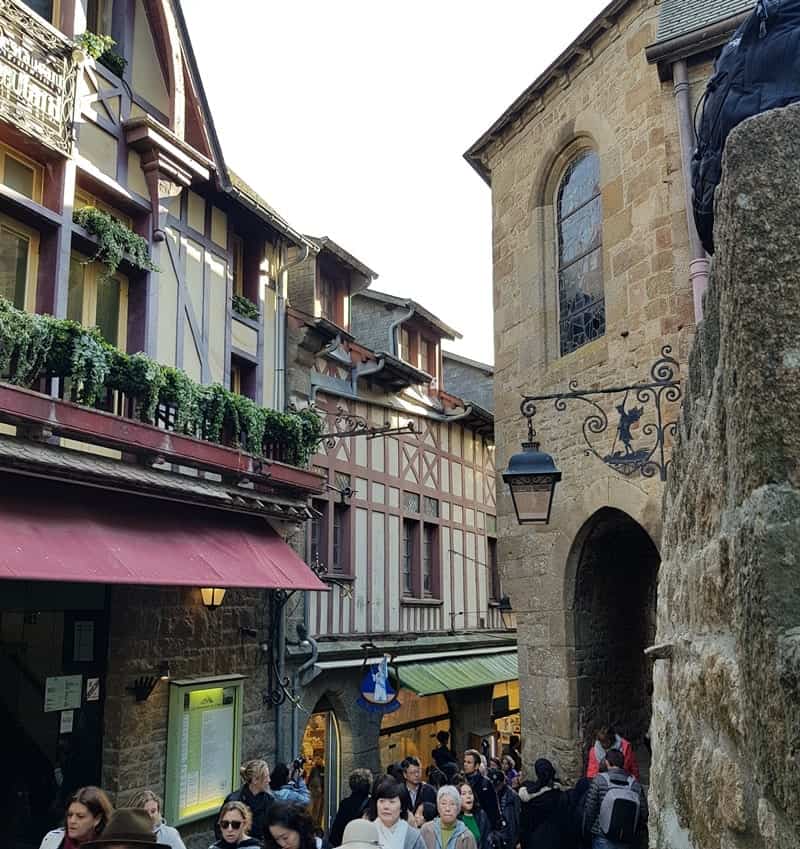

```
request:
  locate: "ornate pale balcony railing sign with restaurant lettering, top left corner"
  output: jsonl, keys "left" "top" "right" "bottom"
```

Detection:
{"left": 0, "top": 0, "right": 78, "bottom": 156}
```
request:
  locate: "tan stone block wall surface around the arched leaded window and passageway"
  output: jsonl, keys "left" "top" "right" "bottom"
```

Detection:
{"left": 488, "top": 0, "right": 694, "bottom": 776}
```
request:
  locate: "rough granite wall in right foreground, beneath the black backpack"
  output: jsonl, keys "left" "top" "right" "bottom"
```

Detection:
{"left": 651, "top": 106, "right": 800, "bottom": 849}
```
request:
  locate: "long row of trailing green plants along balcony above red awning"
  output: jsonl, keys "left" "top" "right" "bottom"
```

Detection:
{"left": 0, "top": 298, "right": 322, "bottom": 466}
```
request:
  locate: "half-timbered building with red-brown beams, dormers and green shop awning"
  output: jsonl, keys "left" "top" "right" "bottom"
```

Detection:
{"left": 283, "top": 239, "right": 519, "bottom": 825}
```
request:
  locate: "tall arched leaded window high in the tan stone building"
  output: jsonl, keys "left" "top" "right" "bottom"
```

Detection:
{"left": 556, "top": 150, "right": 606, "bottom": 356}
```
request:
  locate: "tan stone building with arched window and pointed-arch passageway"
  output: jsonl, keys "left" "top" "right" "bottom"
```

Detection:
{"left": 465, "top": 0, "right": 752, "bottom": 776}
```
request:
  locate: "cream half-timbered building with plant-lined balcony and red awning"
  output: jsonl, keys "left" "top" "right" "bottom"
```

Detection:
{"left": 0, "top": 0, "right": 324, "bottom": 847}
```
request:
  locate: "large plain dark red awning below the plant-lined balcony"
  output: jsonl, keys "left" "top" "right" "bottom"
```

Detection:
{"left": 0, "top": 476, "right": 327, "bottom": 590}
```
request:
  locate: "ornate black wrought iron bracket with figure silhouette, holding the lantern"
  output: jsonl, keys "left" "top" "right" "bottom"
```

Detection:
{"left": 520, "top": 345, "right": 681, "bottom": 481}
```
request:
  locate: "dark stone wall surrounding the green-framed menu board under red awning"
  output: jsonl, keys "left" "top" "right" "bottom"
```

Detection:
{"left": 103, "top": 586, "right": 275, "bottom": 849}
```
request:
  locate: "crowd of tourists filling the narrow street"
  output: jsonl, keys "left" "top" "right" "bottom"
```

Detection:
{"left": 40, "top": 727, "right": 648, "bottom": 849}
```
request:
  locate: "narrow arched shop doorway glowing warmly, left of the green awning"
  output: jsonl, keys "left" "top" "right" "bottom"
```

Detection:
{"left": 300, "top": 699, "right": 341, "bottom": 832}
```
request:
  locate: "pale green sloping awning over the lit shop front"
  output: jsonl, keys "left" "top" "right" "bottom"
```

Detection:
{"left": 397, "top": 651, "right": 519, "bottom": 696}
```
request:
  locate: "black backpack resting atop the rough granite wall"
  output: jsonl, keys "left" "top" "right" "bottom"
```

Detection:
{"left": 692, "top": 0, "right": 800, "bottom": 254}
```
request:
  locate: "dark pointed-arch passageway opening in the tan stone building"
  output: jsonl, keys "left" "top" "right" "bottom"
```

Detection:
{"left": 571, "top": 507, "right": 660, "bottom": 779}
